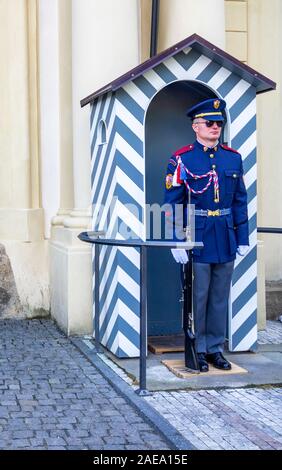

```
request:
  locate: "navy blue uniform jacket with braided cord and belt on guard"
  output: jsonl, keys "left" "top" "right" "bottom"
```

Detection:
{"left": 165, "top": 141, "right": 249, "bottom": 263}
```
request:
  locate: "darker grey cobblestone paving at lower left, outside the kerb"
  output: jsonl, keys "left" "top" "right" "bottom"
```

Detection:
{"left": 0, "top": 320, "right": 169, "bottom": 450}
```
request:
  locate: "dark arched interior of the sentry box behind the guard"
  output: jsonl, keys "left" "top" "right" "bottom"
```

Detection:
{"left": 145, "top": 81, "right": 227, "bottom": 336}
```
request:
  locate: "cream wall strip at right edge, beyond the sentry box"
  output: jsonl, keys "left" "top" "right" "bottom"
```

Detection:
{"left": 248, "top": 0, "right": 282, "bottom": 280}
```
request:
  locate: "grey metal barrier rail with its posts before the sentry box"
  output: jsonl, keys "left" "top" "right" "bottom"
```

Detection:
{"left": 78, "top": 232, "right": 203, "bottom": 396}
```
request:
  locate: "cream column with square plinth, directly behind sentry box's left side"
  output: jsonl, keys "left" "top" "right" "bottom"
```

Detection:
{"left": 51, "top": 0, "right": 139, "bottom": 334}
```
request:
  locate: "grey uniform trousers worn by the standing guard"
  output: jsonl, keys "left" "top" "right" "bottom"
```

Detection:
{"left": 193, "top": 261, "right": 234, "bottom": 353}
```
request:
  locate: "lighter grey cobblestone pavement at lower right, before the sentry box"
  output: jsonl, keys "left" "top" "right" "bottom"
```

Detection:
{"left": 146, "top": 388, "right": 282, "bottom": 450}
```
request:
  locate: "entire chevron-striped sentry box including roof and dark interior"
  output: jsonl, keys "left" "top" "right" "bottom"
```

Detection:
{"left": 81, "top": 34, "right": 275, "bottom": 357}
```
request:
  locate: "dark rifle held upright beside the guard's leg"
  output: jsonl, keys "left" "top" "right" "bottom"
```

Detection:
{"left": 181, "top": 253, "right": 200, "bottom": 373}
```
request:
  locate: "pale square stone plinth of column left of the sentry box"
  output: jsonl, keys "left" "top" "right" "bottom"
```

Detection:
{"left": 50, "top": 226, "right": 93, "bottom": 335}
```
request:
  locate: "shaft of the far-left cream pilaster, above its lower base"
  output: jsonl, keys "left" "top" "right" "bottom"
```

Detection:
{"left": 0, "top": 0, "right": 43, "bottom": 242}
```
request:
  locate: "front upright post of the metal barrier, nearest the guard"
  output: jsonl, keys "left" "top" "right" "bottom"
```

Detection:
{"left": 136, "top": 246, "right": 150, "bottom": 396}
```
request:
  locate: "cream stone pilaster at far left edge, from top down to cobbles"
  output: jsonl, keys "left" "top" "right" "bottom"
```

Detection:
{"left": 0, "top": 0, "right": 49, "bottom": 316}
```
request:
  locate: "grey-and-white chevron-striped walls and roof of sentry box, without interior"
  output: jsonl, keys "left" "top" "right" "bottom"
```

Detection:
{"left": 81, "top": 34, "right": 275, "bottom": 357}
